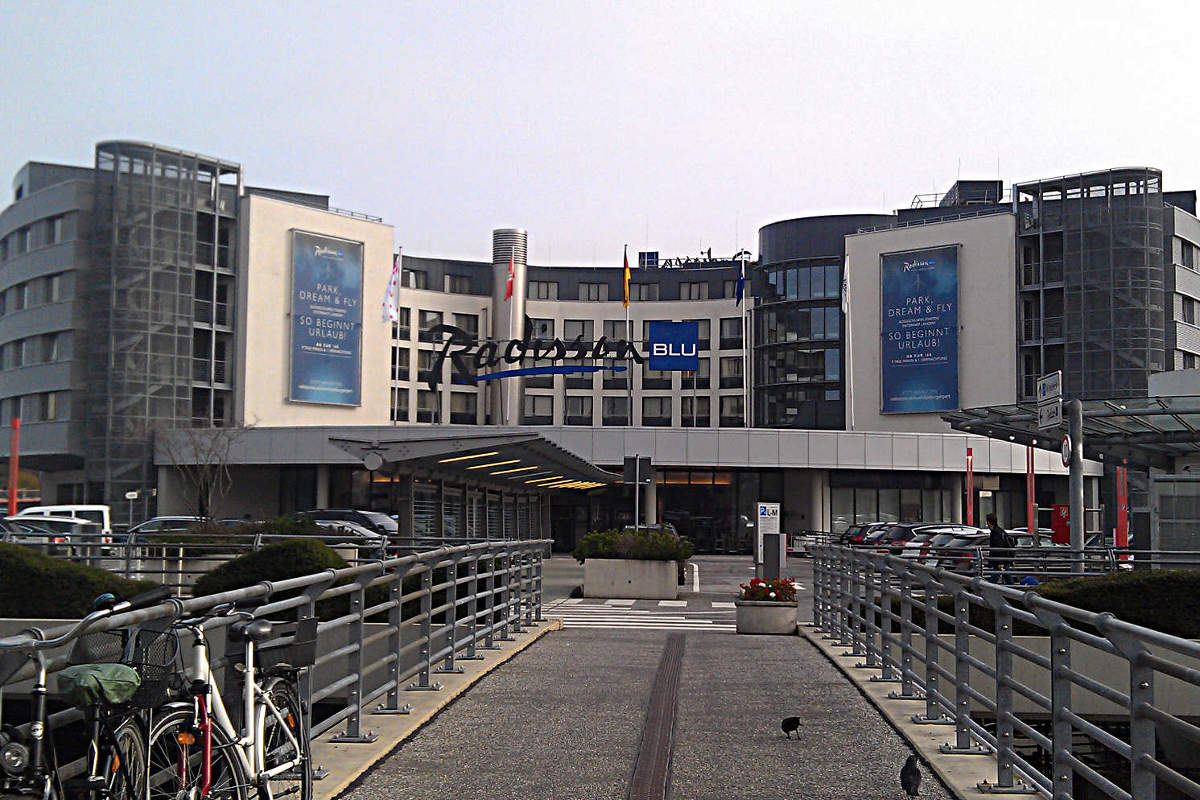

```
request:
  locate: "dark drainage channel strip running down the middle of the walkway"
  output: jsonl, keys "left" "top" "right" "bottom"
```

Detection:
{"left": 625, "top": 633, "right": 684, "bottom": 800}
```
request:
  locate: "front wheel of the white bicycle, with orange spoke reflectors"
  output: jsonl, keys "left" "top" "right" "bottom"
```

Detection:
{"left": 144, "top": 709, "right": 248, "bottom": 800}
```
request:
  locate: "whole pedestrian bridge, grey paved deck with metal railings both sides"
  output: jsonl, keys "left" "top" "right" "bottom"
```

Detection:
{"left": 0, "top": 541, "right": 1200, "bottom": 800}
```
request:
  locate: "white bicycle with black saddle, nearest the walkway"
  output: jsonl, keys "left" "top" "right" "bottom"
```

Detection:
{"left": 148, "top": 603, "right": 317, "bottom": 800}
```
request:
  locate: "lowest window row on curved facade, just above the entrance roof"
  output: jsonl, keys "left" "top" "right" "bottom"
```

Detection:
{"left": 391, "top": 387, "right": 745, "bottom": 427}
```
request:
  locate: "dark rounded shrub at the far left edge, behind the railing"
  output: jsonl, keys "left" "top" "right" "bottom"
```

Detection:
{"left": 0, "top": 543, "right": 155, "bottom": 619}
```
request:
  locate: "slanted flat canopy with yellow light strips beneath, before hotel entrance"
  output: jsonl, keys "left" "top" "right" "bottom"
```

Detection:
{"left": 329, "top": 428, "right": 622, "bottom": 491}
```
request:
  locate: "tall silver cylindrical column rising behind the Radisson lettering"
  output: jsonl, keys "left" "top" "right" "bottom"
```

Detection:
{"left": 488, "top": 228, "right": 528, "bottom": 425}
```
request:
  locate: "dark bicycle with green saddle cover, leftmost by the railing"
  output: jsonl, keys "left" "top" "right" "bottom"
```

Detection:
{"left": 0, "top": 587, "right": 170, "bottom": 800}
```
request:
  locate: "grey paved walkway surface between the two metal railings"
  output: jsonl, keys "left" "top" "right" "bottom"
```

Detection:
{"left": 343, "top": 561, "right": 949, "bottom": 800}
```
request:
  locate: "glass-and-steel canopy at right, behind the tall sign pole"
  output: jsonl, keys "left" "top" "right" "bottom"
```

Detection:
{"left": 942, "top": 397, "right": 1200, "bottom": 469}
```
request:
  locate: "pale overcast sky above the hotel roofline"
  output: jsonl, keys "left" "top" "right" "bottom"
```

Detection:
{"left": 0, "top": 0, "right": 1200, "bottom": 265}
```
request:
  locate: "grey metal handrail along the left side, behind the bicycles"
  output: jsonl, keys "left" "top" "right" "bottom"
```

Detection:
{"left": 0, "top": 540, "right": 552, "bottom": 758}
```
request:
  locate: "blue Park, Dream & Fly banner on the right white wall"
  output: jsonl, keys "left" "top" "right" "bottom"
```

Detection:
{"left": 880, "top": 245, "right": 959, "bottom": 414}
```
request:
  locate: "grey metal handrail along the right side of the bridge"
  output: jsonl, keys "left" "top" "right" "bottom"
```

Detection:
{"left": 810, "top": 545, "right": 1200, "bottom": 800}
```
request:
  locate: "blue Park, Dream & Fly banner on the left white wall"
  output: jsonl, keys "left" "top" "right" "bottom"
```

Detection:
{"left": 289, "top": 230, "right": 362, "bottom": 405}
